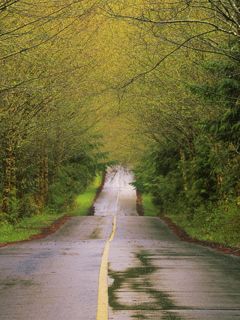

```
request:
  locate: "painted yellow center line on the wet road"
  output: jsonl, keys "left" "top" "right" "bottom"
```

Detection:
{"left": 97, "top": 216, "right": 117, "bottom": 320}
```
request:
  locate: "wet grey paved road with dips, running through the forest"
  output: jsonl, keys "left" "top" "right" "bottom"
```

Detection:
{"left": 0, "top": 168, "right": 240, "bottom": 320}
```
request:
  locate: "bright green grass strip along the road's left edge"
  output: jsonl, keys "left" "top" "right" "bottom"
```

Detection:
{"left": 0, "top": 175, "right": 102, "bottom": 243}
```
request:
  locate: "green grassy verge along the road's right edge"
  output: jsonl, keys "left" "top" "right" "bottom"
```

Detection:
{"left": 142, "top": 193, "right": 240, "bottom": 248}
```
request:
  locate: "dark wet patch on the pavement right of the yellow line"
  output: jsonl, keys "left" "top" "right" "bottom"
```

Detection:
{"left": 108, "top": 252, "right": 183, "bottom": 320}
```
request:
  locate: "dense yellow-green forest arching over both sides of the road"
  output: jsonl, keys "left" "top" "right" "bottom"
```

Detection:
{"left": 0, "top": 0, "right": 240, "bottom": 246}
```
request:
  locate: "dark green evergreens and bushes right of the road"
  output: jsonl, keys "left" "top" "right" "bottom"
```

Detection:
{"left": 134, "top": 52, "right": 240, "bottom": 246}
